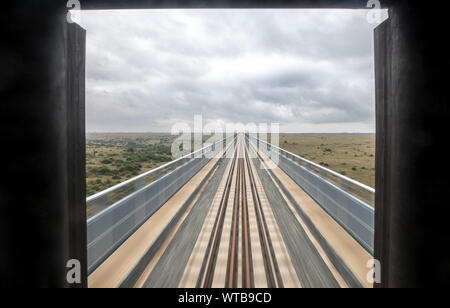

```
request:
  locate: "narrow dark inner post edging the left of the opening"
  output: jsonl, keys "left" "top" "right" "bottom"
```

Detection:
{"left": 67, "top": 24, "right": 87, "bottom": 287}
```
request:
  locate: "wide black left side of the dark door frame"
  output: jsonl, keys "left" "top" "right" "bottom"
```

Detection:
{"left": 0, "top": 1, "right": 87, "bottom": 287}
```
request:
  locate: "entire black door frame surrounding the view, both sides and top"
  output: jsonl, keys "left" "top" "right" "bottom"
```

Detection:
{"left": 0, "top": 0, "right": 450, "bottom": 287}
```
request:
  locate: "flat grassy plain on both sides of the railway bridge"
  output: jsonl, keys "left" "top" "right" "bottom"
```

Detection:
{"left": 86, "top": 133, "right": 375, "bottom": 196}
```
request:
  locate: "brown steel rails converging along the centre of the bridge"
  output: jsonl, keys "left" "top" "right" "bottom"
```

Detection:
{"left": 196, "top": 140, "right": 283, "bottom": 288}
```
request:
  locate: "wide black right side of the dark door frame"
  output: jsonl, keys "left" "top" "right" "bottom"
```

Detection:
{"left": 375, "top": 1, "right": 450, "bottom": 287}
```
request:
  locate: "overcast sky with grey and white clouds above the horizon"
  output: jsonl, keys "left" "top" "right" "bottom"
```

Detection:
{"left": 81, "top": 10, "right": 386, "bottom": 133}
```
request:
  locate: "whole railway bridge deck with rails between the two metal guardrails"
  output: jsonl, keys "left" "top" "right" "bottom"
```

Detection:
{"left": 91, "top": 135, "right": 365, "bottom": 288}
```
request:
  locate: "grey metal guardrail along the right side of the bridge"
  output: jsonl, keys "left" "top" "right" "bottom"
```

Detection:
{"left": 250, "top": 136, "right": 375, "bottom": 255}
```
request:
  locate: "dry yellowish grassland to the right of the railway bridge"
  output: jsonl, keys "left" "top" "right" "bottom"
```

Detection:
{"left": 280, "top": 134, "right": 375, "bottom": 187}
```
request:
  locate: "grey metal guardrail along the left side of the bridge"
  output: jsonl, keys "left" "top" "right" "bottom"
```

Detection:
{"left": 87, "top": 137, "right": 233, "bottom": 274}
